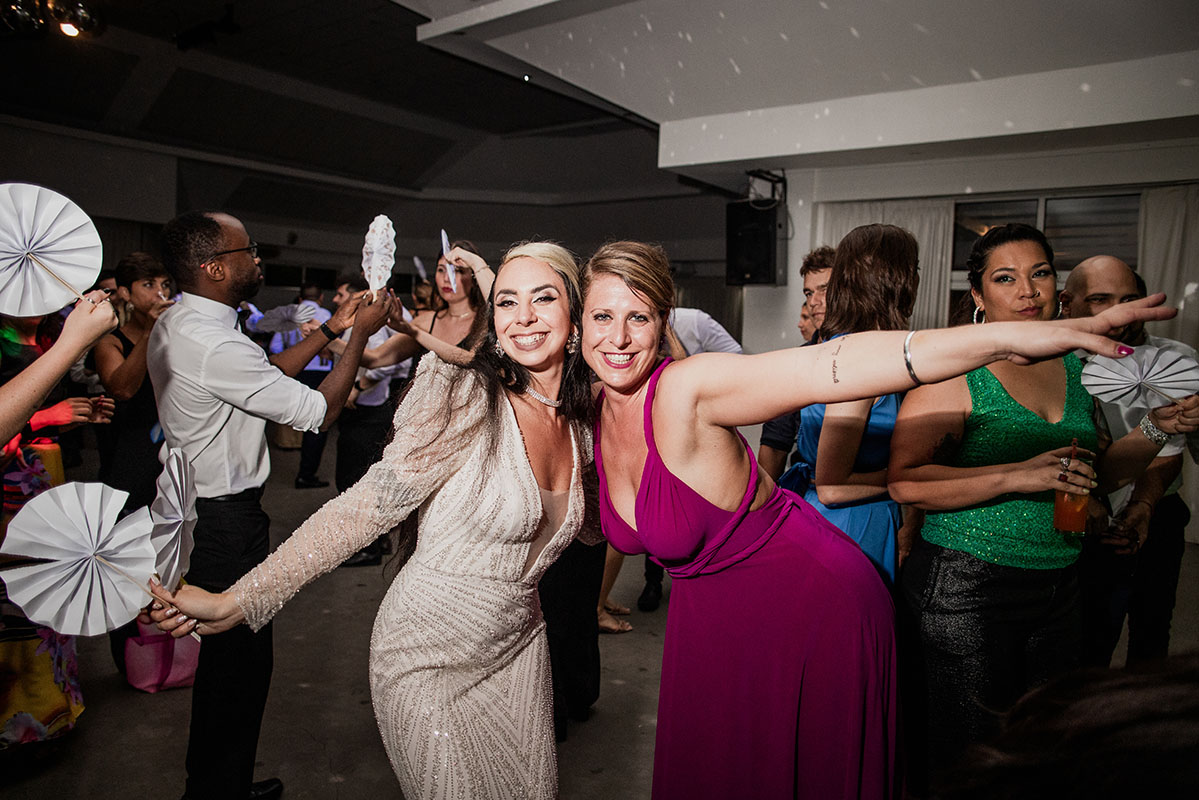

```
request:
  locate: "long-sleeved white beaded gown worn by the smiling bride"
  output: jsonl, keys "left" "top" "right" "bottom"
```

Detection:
{"left": 233, "top": 353, "right": 600, "bottom": 800}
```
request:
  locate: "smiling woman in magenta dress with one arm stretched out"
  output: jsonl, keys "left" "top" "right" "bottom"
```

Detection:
{"left": 583, "top": 242, "right": 1171, "bottom": 800}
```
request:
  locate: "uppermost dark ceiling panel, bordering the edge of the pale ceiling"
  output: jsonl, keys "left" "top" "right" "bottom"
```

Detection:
{"left": 110, "top": 0, "right": 605, "bottom": 133}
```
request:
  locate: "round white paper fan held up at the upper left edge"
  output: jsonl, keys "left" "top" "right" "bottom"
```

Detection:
{"left": 0, "top": 184, "right": 103, "bottom": 317}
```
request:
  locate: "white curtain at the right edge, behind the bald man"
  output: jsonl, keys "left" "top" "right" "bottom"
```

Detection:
{"left": 1137, "top": 184, "right": 1199, "bottom": 542}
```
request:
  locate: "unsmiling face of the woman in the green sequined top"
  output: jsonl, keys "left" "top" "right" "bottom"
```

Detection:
{"left": 970, "top": 241, "right": 1058, "bottom": 323}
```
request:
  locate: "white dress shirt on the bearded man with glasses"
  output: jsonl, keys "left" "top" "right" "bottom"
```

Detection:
{"left": 146, "top": 291, "right": 326, "bottom": 498}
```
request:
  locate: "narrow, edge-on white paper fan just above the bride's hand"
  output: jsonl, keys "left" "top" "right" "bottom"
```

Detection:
{"left": 150, "top": 447, "right": 195, "bottom": 591}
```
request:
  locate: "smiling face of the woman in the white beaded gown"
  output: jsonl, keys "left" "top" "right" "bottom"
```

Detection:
{"left": 493, "top": 255, "right": 572, "bottom": 373}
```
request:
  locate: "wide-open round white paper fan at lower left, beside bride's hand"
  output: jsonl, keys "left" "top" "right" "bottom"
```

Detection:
{"left": 0, "top": 483, "right": 155, "bottom": 636}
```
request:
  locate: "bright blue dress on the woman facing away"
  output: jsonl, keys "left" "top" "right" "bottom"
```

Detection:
{"left": 778, "top": 395, "right": 903, "bottom": 584}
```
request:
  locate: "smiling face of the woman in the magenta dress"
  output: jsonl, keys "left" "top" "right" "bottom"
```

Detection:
{"left": 583, "top": 273, "right": 663, "bottom": 392}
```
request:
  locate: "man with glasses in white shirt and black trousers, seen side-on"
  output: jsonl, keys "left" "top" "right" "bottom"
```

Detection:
{"left": 146, "top": 211, "right": 388, "bottom": 800}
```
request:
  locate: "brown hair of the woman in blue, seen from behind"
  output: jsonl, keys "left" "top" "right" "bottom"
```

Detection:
{"left": 820, "top": 223, "right": 920, "bottom": 338}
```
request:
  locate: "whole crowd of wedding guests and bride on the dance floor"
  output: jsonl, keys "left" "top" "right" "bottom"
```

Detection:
{"left": 0, "top": 212, "right": 1199, "bottom": 800}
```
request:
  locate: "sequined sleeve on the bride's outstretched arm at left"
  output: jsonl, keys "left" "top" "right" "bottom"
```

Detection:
{"left": 231, "top": 353, "right": 487, "bottom": 631}
